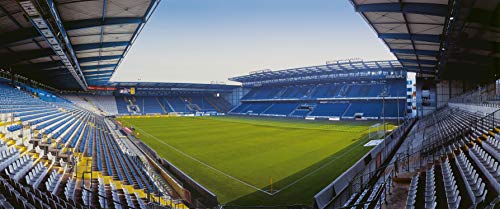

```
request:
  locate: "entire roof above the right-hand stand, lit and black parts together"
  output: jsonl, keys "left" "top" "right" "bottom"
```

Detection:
{"left": 351, "top": 0, "right": 500, "bottom": 79}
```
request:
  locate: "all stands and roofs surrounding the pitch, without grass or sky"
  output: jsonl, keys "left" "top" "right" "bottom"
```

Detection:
{"left": 0, "top": 0, "right": 500, "bottom": 209}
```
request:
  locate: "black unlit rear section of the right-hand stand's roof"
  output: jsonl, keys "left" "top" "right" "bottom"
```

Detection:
{"left": 440, "top": 0, "right": 500, "bottom": 82}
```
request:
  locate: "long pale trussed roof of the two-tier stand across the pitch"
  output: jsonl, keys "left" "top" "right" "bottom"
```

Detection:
{"left": 229, "top": 60, "right": 402, "bottom": 83}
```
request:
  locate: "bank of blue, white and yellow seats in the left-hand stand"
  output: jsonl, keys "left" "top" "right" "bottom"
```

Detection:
{"left": 0, "top": 83, "right": 173, "bottom": 208}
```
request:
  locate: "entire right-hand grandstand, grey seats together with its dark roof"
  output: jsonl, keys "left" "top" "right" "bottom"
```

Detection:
{"left": 314, "top": 0, "right": 500, "bottom": 208}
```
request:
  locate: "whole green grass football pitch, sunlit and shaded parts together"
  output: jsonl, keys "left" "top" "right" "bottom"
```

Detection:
{"left": 118, "top": 117, "right": 382, "bottom": 206}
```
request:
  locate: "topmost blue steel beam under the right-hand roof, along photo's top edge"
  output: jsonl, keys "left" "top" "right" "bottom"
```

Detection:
{"left": 356, "top": 3, "right": 448, "bottom": 17}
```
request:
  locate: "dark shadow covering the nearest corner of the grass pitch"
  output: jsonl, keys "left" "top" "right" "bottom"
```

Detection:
{"left": 225, "top": 134, "right": 373, "bottom": 208}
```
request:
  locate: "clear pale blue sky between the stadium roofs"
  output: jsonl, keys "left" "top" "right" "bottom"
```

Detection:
{"left": 112, "top": 0, "right": 394, "bottom": 83}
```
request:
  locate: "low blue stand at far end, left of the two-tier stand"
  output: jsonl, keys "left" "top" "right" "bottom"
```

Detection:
{"left": 106, "top": 83, "right": 238, "bottom": 115}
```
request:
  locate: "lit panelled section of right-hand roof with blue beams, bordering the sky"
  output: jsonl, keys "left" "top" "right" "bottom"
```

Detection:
{"left": 351, "top": 0, "right": 448, "bottom": 73}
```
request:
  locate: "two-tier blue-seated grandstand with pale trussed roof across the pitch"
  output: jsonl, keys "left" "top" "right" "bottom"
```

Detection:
{"left": 229, "top": 61, "right": 412, "bottom": 120}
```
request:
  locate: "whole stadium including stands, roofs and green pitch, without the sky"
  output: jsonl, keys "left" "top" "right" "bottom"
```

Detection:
{"left": 0, "top": 0, "right": 500, "bottom": 209}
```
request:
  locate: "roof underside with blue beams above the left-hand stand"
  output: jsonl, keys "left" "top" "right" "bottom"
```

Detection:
{"left": 0, "top": 0, "right": 160, "bottom": 90}
